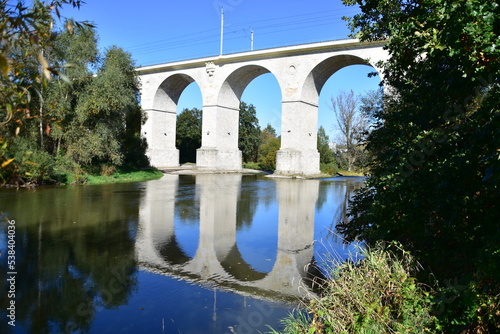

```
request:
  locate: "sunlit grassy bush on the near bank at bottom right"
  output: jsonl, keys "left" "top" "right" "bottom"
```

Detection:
{"left": 276, "top": 244, "right": 435, "bottom": 333}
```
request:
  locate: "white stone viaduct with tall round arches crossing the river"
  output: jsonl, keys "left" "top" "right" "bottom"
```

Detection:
{"left": 137, "top": 39, "right": 388, "bottom": 175}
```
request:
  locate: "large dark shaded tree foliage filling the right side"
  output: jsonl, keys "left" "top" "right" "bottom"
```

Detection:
{"left": 339, "top": 0, "right": 500, "bottom": 332}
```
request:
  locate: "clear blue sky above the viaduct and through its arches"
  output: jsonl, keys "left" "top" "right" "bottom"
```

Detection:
{"left": 63, "top": 0, "right": 380, "bottom": 140}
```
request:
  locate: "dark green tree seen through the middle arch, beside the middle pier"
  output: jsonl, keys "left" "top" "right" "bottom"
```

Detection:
{"left": 238, "top": 101, "right": 260, "bottom": 162}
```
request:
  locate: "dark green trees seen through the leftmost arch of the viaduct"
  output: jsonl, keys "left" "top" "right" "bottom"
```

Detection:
{"left": 175, "top": 108, "right": 201, "bottom": 163}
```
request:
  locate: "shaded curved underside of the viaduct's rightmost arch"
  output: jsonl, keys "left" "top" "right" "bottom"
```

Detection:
{"left": 302, "top": 55, "right": 372, "bottom": 104}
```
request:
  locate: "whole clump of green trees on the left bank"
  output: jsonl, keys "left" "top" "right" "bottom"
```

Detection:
{"left": 0, "top": 1, "right": 148, "bottom": 183}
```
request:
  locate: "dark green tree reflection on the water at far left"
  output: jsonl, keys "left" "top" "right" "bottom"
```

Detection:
{"left": 0, "top": 185, "right": 138, "bottom": 333}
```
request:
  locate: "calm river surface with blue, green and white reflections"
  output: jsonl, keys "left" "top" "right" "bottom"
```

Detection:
{"left": 0, "top": 174, "right": 362, "bottom": 333}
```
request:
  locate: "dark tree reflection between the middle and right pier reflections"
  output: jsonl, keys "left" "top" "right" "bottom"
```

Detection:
{"left": 236, "top": 175, "right": 259, "bottom": 230}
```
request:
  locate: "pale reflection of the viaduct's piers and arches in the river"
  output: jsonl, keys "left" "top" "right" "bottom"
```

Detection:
{"left": 136, "top": 174, "right": 319, "bottom": 298}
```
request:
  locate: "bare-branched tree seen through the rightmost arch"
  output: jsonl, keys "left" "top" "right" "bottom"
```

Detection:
{"left": 331, "top": 90, "right": 368, "bottom": 171}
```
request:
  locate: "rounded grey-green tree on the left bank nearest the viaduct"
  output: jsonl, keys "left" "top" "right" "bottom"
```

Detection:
{"left": 65, "top": 47, "right": 139, "bottom": 165}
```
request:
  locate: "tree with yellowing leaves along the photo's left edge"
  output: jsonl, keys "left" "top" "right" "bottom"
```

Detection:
{"left": 0, "top": 0, "right": 88, "bottom": 182}
